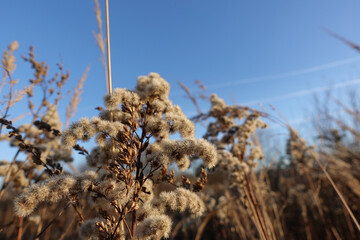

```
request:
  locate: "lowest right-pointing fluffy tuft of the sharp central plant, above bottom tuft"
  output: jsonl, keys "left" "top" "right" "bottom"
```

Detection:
{"left": 154, "top": 188, "right": 205, "bottom": 216}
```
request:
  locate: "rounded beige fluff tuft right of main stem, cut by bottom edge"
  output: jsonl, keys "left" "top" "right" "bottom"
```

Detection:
{"left": 135, "top": 215, "right": 172, "bottom": 240}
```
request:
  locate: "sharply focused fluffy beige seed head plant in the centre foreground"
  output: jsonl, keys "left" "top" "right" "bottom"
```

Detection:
{"left": 15, "top": 73, "right": 218, "bottom": 239}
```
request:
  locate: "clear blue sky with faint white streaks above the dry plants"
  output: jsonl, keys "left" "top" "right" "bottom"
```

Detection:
{"left": 0, "top": 0, "right": 360, "bottom": 148}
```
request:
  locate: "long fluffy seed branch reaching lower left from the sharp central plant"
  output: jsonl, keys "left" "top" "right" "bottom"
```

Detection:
{"left": 15, "top": 171, "right": 97, "bottom": 217}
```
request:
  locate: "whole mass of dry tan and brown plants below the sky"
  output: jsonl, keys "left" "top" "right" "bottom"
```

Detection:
{"left": 0, "top": 0, "right": 360, "bottom": 240}
